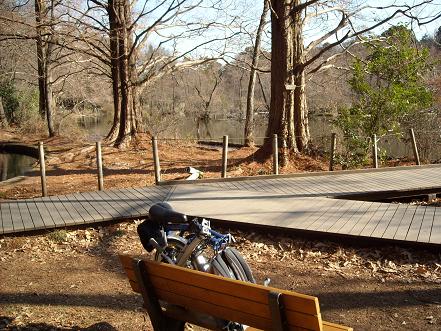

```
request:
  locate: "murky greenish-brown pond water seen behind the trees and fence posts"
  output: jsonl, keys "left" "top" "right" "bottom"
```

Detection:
{"left": 80, "top": 113, "right": 441, "bottom": 162}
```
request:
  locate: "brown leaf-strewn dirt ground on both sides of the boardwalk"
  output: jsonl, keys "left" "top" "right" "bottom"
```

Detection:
{"left": 0, "top": 133, "right": 441, "bottom": 331}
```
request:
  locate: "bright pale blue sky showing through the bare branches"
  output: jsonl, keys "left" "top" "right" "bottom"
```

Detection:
{"left": 142, "top": 0, "right": 441, "bottom": 56}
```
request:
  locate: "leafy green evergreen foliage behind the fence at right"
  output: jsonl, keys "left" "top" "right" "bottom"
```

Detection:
{"left": 336, "top": 26, "right": 433, "bottom": 166}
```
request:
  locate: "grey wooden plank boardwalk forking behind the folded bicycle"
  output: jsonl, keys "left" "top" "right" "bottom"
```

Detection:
{"left": 0, "top": 166, "right": 441, "bottom": 245}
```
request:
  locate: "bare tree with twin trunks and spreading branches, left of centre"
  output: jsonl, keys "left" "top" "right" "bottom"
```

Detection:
{"left": 62, "top": 0, "right": 246, "bottom": 147}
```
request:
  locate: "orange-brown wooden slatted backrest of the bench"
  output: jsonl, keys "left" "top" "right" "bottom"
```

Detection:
{"left": 120, "top": 255, "right": 336, "bottom": 330}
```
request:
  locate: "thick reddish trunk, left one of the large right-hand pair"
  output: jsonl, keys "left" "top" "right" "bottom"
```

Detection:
{"left": 263, "top": 0, "right": 298, "bottom": 166}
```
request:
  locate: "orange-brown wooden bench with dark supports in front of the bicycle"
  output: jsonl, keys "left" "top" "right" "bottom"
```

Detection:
{"left": 120, "top": 255, "right": 352, "bottom": 331}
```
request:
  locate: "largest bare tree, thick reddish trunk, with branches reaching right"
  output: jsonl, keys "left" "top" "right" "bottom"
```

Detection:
{"left": 260, "top": 0, "right": 440, "bottom": 164}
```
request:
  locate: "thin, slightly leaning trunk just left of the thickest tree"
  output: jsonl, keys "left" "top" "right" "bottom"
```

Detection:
{"left": 244, "top": 0, "right": 269, "bottom": 146}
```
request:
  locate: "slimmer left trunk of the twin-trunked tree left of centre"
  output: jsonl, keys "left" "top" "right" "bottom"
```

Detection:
{"left": 106, "top": 0, "right": 121, "bottom": 142}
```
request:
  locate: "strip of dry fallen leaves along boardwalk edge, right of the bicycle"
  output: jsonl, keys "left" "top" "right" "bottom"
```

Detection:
{"left": 234, "top": 231, "right": 441, "bottom": 284}
